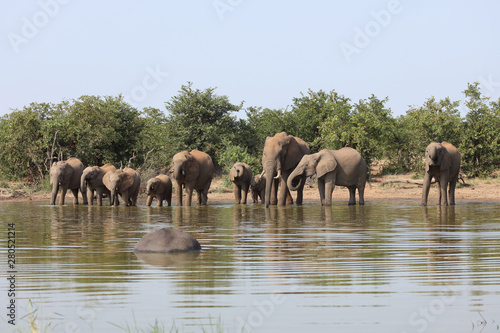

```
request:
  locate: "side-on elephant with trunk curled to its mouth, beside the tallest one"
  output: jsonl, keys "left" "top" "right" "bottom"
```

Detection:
{"left": 287, "top": 147, "right": 368, "bottom": 206}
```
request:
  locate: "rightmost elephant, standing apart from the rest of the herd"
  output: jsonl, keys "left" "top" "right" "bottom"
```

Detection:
{"left": 422, "top": 141, "right": 461, "bottom": 206}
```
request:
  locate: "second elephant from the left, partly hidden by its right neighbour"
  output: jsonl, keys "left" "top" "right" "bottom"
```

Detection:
{"left": 80, "top": 163, "right": 116, "bottom": 206}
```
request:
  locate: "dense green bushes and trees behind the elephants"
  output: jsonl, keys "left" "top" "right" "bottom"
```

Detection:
{"left": 0, "top": 83, "right": 500, "bottom": 181}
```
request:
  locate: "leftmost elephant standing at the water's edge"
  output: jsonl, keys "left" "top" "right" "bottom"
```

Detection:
{"left": 50, "top": 157, "right": 87, "bottom": 205}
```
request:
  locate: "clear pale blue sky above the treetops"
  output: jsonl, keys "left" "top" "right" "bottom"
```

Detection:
{"left": 0, "top": 0, "right": 500, "bottom": 116}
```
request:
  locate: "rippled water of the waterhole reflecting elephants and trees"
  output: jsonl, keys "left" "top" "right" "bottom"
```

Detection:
{"left": 0, "top": 198, "right": 500, "bottom": 332}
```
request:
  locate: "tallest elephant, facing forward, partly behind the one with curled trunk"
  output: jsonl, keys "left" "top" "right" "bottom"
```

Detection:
{"left": 262, "top": 132, "right": 309, "bottom": 207}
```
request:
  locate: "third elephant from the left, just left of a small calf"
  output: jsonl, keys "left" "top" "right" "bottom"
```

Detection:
{"left": 102, "top": 168, "right": 141, "bottom": 206}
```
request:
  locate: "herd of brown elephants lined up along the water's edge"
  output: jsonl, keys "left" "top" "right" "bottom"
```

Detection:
{"left": 50, "top": 132, "right": 460, "bottom": 208}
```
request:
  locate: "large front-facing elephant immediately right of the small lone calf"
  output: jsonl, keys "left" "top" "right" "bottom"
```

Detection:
{"left": 170, "top": 149, "right": 215, "bottom": 206}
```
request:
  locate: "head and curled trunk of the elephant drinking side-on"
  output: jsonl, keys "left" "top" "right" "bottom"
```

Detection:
{"left": 287, "top": 149, "right": 337, "bottom": 191}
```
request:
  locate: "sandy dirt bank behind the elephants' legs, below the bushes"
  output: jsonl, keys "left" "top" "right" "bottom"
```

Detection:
{"left": 0, "top": 175, "right": 500, "bottom": 205}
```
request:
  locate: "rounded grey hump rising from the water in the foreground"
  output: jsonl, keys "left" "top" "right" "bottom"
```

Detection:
{"left": 134, "top": 228, "right": 201, "bottom": 253}
